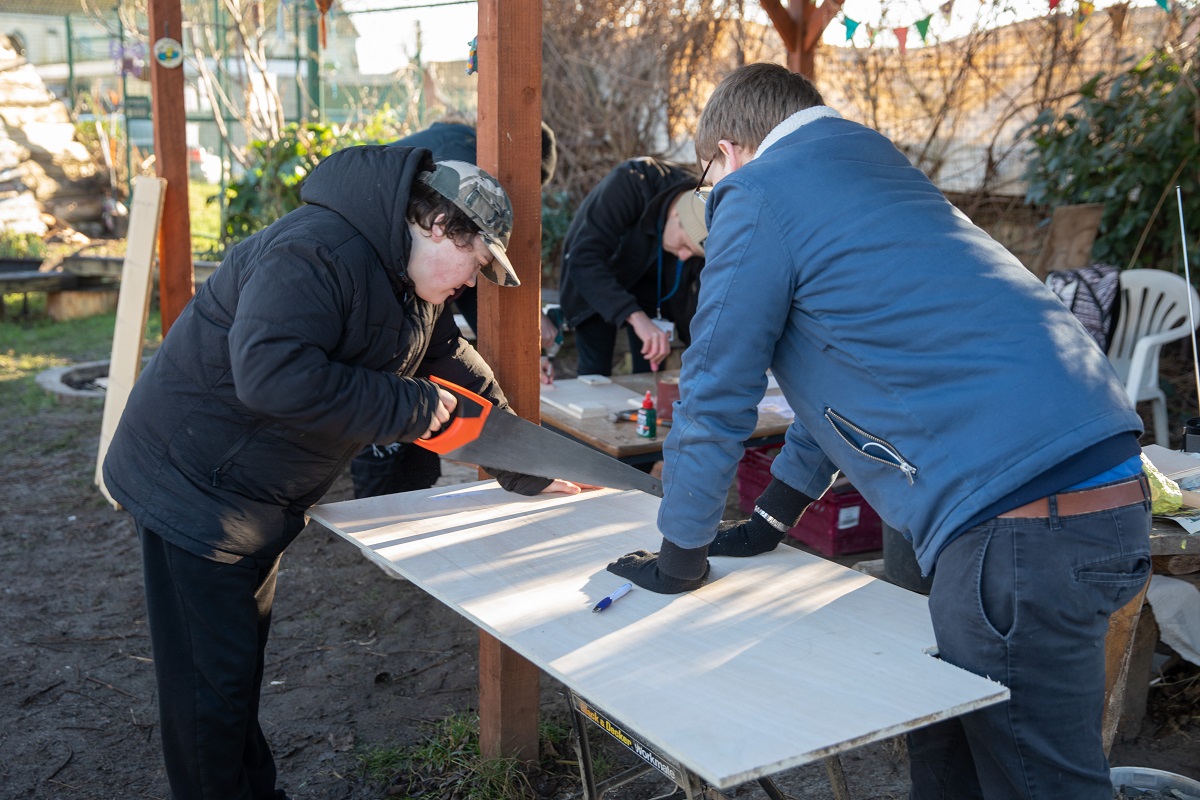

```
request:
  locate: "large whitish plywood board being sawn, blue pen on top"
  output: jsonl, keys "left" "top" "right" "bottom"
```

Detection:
{"left": 310, "top": 481, "right": 1007, "bottom": 788}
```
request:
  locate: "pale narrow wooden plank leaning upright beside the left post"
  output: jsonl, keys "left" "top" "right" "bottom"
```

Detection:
{"left": 95, "top": 176, "right": 167, "bottom": 507}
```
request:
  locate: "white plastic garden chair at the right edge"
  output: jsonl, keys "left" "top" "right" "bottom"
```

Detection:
{"left": 1109, "top": 270, "right": 1200, "bottom": 447}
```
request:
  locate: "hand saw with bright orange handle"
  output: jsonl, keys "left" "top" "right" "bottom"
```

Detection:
{"left": 416, "top": 378, "right": 662, "bottom": 498}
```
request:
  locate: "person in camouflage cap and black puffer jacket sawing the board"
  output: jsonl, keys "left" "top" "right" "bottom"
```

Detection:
{"left": 103, "top": 146, "right": 581, "bottom": 800}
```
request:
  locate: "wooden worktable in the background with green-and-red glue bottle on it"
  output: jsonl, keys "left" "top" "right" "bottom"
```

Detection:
{"left": 541, "top": 369, "right": 792, "bottom": 464}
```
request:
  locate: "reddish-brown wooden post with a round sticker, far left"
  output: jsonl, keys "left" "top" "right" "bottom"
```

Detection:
{"left": 149, "top": 0, "right": 196, "bottom": 336}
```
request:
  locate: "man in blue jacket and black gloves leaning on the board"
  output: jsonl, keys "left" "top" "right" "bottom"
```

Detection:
{"left": 608, "top": 64, "right": 1151, "bottom": 800}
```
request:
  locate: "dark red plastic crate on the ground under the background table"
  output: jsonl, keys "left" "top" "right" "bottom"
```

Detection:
{"left": 738, "top": 447, "right": 883, "bottom": 555}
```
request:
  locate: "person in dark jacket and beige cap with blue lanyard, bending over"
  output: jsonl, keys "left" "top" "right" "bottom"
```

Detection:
{"left": 559, "top": 158, "right": 708, "bottom": 375}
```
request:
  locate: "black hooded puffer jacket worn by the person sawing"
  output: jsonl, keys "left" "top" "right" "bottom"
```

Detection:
{"left": 104, "top": 146, "right": 525, "bottom": 561}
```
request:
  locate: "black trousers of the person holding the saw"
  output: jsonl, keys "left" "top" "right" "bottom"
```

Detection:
{"left": 138, "top": 525, "right": 286, "bottom": 800}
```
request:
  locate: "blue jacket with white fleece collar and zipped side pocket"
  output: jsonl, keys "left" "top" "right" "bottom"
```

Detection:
{"left": 659, "top": 115, "right": 1141, "bottom": 572}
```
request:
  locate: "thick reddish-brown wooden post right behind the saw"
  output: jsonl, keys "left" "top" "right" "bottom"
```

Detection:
{"left": 475, "top": 0, "right": 541, "bottom": 759}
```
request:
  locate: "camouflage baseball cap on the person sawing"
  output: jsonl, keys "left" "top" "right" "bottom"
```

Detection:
{"left": 416, "top": 161, "right": 521, "bottom": 287}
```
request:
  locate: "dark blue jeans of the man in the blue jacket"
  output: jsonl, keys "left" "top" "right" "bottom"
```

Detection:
{"left": 908, "top": 489, "right": 1151, "bottom": 800}
